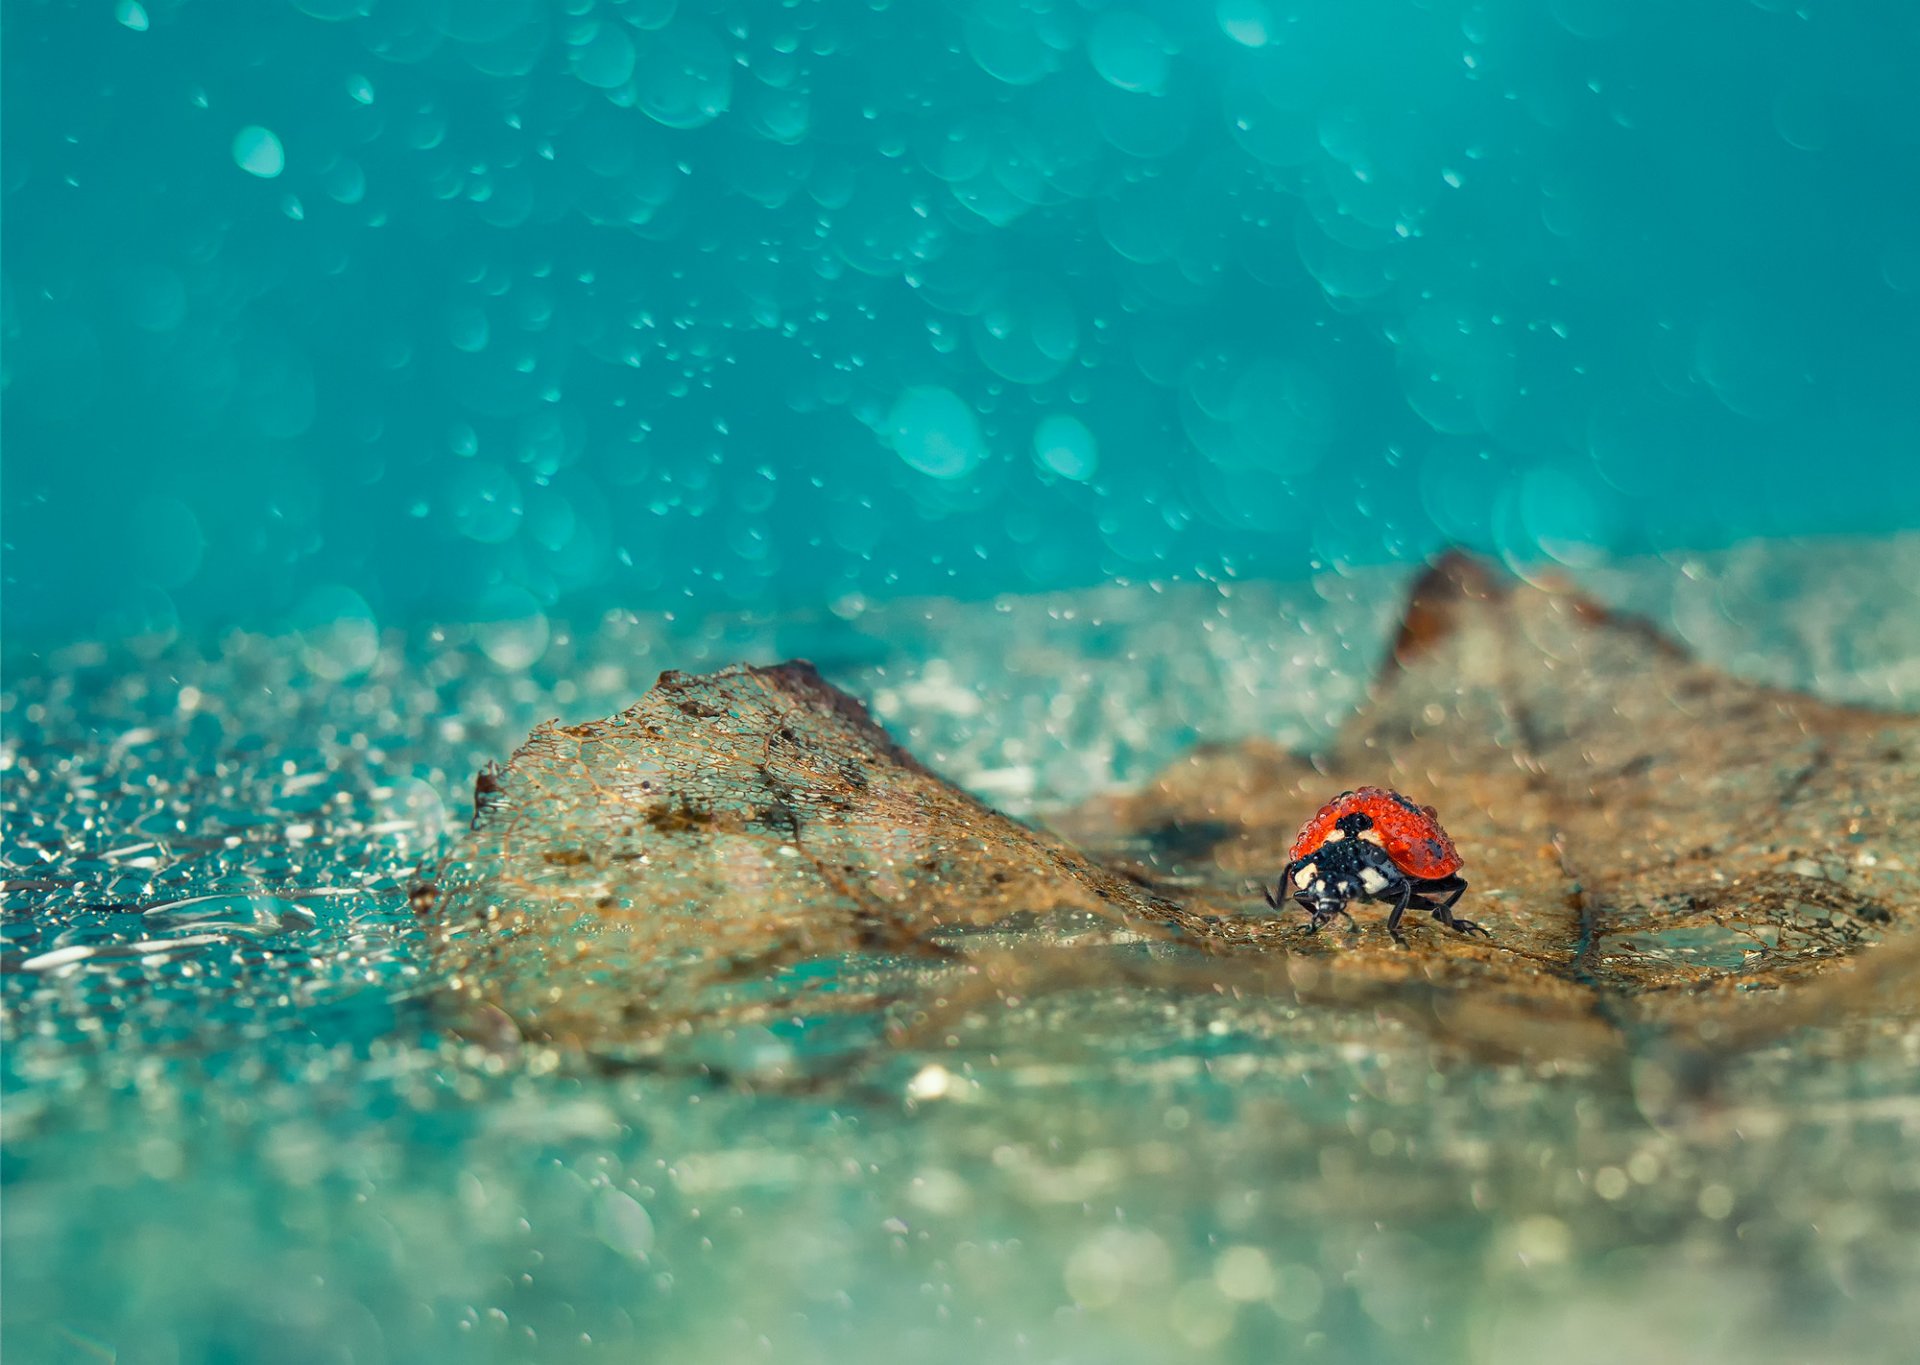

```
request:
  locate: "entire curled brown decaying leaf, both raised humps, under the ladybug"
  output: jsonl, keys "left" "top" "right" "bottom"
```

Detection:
{"left": 422, "top": 557, "right": 1920, "bottom": 1060}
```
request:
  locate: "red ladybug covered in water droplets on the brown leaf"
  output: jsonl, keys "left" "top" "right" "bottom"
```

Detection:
{"left": 1263, "top": 787, "right": 1494, "bottom": 939}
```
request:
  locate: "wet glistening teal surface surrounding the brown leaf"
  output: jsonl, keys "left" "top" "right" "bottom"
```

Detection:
{"left": 4, "top": 539, "right": 1920, "bottom": 1361}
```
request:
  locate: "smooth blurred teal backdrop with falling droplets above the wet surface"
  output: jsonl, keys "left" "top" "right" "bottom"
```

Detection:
{"left": 4, "top": 0, "right": 1920, "bottom": 635}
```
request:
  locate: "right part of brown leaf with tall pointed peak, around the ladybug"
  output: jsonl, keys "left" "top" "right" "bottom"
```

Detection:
{"left": 1071, "top": 557, "right": 1920, "bottom": 1054}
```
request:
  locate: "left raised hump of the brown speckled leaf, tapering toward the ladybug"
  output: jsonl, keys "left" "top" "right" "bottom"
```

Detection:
{"left": 428, "top": 664, "right": 1173, "bottom": 1046}
